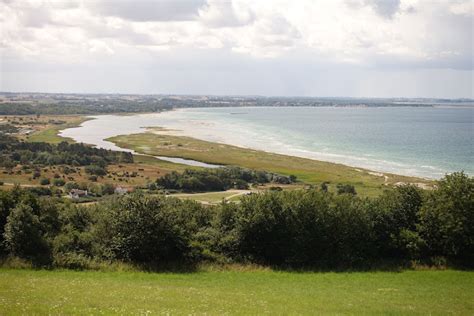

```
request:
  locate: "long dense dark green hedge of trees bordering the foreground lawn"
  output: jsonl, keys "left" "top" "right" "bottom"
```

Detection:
{"left": 0, "top": 173, "right": 474, "bottom": 268}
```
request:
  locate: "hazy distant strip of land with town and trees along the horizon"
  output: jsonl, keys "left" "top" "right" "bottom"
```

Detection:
{"left": 0, "top": 92, "right": 474, "bottom": 115}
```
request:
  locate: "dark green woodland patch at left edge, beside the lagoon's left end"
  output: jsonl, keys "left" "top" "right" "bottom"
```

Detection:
{"left": 0, "top": 134, "right": 133, "bottom": 168}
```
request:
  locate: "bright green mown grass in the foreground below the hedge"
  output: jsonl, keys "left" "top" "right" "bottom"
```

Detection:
{"left": 0, "top": 269, "right": 474, "bottom": 315}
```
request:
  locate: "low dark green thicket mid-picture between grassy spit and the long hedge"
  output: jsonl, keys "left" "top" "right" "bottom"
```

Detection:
{"left": 156, "top": 167, "right": 296, "bottom": 192}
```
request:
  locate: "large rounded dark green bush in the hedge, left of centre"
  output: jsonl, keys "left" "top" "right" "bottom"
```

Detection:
{"left": 97, "top": 194, "right": 191, "bottom": 265}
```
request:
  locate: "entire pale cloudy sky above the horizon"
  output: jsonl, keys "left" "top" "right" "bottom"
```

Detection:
{"left": 0, "top": 0, "right": 474, "bottom": 98}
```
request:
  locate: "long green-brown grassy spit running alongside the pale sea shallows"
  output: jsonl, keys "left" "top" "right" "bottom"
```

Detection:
{"left": 108, "top": 133, "right": 429, "bottom": 195}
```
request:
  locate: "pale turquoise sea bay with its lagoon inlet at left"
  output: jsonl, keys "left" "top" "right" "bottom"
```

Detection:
{"left": 63, "top": 107, "right": 474, "bottom": 178}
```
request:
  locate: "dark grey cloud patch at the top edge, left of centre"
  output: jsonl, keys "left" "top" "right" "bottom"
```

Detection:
{"left": 88, "top": 0, "right": 205, "bottom": 22}
